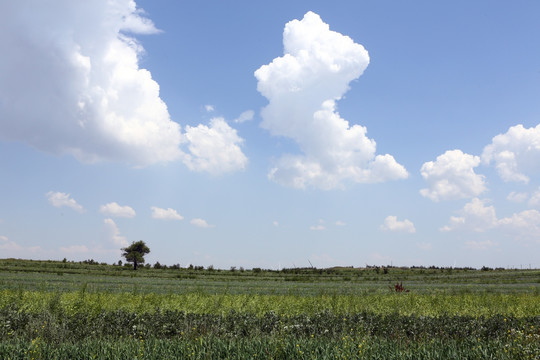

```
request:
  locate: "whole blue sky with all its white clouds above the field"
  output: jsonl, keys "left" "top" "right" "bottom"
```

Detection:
{"left": 0, "top": 0, "right": 540, "bottom": 269}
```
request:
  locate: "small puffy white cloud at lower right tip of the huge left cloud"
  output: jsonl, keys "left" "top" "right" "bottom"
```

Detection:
{"left": 183, "top": 118, "right": 248, "bottom": 175}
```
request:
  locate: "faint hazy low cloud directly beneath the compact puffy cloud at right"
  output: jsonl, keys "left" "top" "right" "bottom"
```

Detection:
{"left": 440, "top": 198, "right": 498, "bottom": 232}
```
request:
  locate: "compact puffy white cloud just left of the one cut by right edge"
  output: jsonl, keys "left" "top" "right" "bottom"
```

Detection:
{"left": 420, "top": 150, "right": 486, "bottom": 201}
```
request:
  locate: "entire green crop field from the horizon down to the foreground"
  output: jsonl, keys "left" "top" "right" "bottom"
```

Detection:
{"left": 0, "top": 259, "right": 540, "bottom": 359}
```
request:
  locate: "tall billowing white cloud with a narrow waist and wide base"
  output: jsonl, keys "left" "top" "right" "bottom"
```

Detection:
{"left": 255, "top": 12, "right": 408, "bottom": 189}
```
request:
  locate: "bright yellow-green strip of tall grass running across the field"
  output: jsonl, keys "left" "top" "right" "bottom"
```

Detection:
{"left": 0, "top": 285, "right": 540, "bottom": 317}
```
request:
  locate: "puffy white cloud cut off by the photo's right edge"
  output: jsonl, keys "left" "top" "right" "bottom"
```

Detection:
{"left": 482, "top": 124, "right": 540, "bottom": 183}
